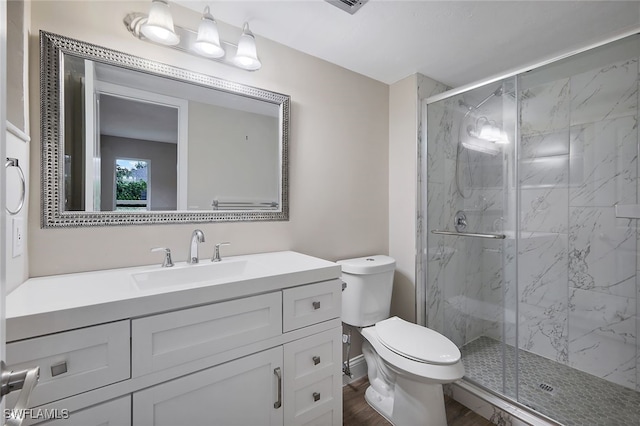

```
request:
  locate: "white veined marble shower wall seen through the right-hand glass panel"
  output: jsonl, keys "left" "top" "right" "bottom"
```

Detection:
{"left": 518, "top": 58, "right": 640, "bottom": 390}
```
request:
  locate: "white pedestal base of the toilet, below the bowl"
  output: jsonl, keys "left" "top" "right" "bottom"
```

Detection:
{"left": 365, "top": 376, "right": 447, "bottom": 426}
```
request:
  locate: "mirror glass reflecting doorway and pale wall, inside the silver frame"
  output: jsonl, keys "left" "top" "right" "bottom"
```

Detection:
{"left": 64, "top": 54, "right": 280, "bottom": 211}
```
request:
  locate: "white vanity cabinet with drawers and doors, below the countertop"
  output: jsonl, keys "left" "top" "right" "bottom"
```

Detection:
{"left": 7, "top": 252, "right": 342, "bottom": 426}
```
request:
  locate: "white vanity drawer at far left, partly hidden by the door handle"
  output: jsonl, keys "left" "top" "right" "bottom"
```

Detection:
{"left": 6, "top": 321, "right": 130, "bottom": 407}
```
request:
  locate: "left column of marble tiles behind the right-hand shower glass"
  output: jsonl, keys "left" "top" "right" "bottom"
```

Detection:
{"left": 517, "top": 78, "right": 571, "bottom": 363}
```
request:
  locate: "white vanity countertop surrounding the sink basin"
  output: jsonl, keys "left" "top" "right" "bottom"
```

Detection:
{"left": 6, "top": 251, "right": 341, "bottom": 342}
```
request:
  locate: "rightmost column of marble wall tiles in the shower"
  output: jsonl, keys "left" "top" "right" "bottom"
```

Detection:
{"left": 569, "top": 59, "right": 639, "bottom": 389}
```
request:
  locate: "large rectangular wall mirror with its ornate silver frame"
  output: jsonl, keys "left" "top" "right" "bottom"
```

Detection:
{"left": 40, "top": 31, "right": 290, "bottom": 227}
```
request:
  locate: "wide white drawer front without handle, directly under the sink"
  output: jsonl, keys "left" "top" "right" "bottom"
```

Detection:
{"left": 131, "top": 292, "right": 282, "bottom": 377}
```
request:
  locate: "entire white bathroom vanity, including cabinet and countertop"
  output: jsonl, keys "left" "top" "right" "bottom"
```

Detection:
{"left": 7, "top": 252, "right": 342, "bottom": 426}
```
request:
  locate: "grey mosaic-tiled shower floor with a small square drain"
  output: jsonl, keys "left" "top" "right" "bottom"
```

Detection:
{"left": 460, "top": 337, "right": 640, "bottom": 426}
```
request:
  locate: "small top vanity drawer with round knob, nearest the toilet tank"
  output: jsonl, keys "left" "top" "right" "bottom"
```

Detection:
{"left": 282, "top": 280, "right": 342, "bottom": 332}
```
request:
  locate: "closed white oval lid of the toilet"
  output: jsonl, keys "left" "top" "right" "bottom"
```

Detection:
{"left": 375, "top": 317, "right": 460, "bottom": 365}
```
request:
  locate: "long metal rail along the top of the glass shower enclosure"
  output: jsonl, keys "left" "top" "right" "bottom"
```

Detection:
{"left": 426, "top": 26, "right": 640, "bottom": 104}
